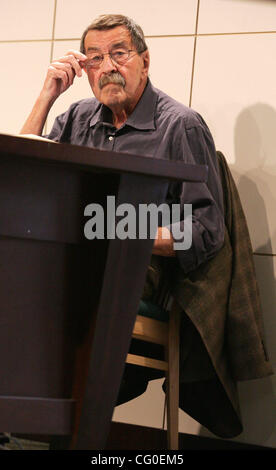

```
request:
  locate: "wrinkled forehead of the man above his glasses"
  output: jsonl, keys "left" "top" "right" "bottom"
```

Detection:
{"left": 84, "top": 26, "right": 132, "bottom": 54}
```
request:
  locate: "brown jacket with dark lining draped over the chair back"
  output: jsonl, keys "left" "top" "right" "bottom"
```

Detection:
{"left": 164, "top": 152, "right": 273, "bottom": 438}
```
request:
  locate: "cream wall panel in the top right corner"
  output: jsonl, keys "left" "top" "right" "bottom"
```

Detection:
{"left": 197, "top": 0, "right": 276, "bottom": 33}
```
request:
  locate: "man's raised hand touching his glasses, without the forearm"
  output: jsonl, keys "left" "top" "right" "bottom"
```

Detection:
{"left": 41, "top": 50, "right": 87, "bottom": 102}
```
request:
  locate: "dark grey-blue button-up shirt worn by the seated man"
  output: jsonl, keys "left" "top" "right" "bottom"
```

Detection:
{"left": 45, "top": 80, "right": 224, "bottom": 272}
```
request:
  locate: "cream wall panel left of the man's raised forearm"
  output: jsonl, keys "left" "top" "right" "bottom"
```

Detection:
{"left": 0, "top": 42, "right": 51, "bottom": 134}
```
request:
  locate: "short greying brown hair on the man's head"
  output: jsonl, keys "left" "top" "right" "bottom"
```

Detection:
{"left": 80, "top": 15, "right": 148, "bottom": 54}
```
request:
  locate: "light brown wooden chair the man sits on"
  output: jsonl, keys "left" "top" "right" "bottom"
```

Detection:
{"left": 126, "top": 300, "right": 180, "bottom": 450}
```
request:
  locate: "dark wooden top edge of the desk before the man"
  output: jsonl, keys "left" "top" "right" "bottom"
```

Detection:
{"left": 0, "top": 134, "right": 208, "bottom": 182}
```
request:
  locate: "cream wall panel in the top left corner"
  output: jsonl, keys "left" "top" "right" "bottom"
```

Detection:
{"left": 0, "top": 0, "right": 54, "bottom": 41}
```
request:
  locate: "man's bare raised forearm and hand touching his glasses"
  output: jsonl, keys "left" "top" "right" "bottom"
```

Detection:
{"left": 20, "top": 50, "right": 87, "bottom": 135}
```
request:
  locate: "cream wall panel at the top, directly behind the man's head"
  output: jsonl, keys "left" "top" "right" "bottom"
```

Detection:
{"left": 55, "top": 0, "right": 197, "bottom": 38}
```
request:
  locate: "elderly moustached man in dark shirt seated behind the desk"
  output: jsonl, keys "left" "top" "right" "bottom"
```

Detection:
{"left": 21, "top": 15, "right": 224, "bottom": 272}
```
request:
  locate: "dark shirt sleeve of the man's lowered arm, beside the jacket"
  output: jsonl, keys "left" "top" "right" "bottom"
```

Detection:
{"left": 168, "top": 115, "right": 224, "bottom": 273}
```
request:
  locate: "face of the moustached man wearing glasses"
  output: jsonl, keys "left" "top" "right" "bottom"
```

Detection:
{"left": 84, "top": 26, "right": 149, "bottom": 111}
